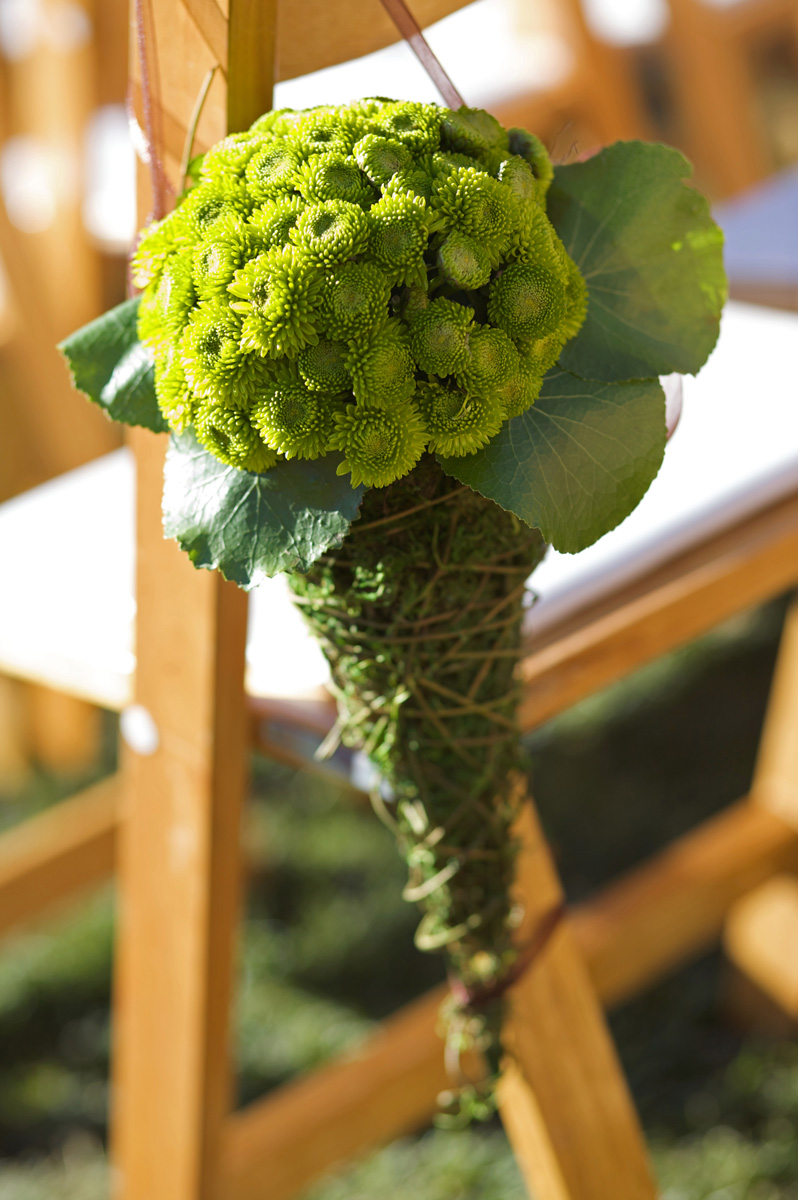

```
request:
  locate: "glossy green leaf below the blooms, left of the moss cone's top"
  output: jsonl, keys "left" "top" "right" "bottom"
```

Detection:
{"left": 163, "top": 431, "right": 365, "bottom": 589}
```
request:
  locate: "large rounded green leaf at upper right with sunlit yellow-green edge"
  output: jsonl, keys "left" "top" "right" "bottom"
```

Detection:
{"left": 547, "top": 142, "right": 726, "bottom": 380}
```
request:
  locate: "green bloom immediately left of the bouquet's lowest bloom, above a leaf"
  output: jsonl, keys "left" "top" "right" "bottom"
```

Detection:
{"left": 251, "top": 368, "right": 336, "bottom": 458}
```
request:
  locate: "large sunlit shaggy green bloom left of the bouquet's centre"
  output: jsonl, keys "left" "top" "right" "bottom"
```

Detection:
{"left": 229, "top": 246, "right": 324, "bottom": 358}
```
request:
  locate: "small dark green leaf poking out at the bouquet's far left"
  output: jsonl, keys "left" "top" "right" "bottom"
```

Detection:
{"left": 59, "top": 296, "right": 168, "bottom": 433}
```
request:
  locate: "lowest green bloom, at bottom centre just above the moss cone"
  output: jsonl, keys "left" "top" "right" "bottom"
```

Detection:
{"left": 330, "top": 400, "right": 427, "bottom": 487}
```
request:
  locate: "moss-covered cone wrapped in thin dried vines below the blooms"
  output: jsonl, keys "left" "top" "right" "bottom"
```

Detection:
{"left": 292, "top": 456, "right": 545, "bottom": 1108}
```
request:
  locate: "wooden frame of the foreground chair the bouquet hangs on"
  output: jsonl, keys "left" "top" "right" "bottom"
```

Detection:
{"left": 0, "top": 0, "right": 798, "bottom": 1200}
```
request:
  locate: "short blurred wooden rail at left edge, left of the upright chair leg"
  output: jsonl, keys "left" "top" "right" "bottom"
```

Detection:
{"left": 0, "top": 776, "right": 121, "bottom": 934}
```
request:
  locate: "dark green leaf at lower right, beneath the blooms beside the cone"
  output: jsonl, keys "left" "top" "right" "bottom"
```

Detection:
{"left": 439, "top": 371, "right": 666, "bottom": 554}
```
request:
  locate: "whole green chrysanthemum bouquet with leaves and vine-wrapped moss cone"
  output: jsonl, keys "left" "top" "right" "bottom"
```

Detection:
{"left": 64, "top": 98, "right": 725, "bottom": 1109}
